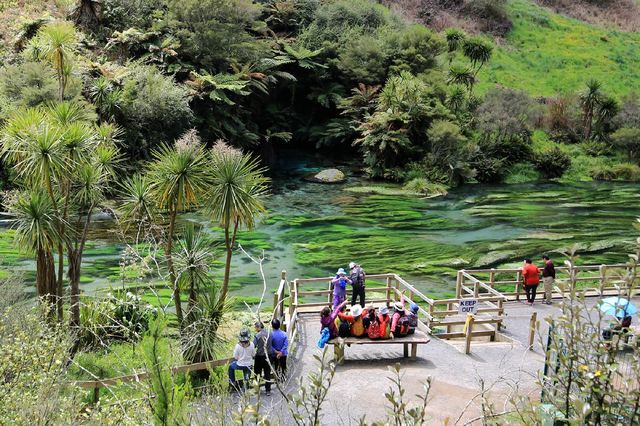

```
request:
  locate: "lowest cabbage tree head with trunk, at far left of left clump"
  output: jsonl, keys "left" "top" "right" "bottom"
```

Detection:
{"left": 9, "top": 188, "right": 63, "bottom": 313}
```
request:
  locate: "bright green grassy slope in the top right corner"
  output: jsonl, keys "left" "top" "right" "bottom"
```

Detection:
{"left": 479, "top": 0, "right": 640, "bottom": 97}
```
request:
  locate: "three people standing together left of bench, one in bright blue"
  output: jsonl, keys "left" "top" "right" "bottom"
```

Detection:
{"left": 229, "top": 318, "right": 289, "bottom": 395}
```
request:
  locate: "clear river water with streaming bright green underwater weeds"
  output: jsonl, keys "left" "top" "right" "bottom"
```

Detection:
{"left": 0, "top": 151, "right": 640, "bottom": 301}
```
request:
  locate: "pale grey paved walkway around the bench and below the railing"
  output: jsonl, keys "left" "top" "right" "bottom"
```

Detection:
{"left": 292, "top": 298, "right": 639, "bottom": 425}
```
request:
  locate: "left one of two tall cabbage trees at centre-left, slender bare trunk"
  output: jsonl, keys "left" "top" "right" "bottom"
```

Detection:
{"left": 148, "top": 140, "right": 209, "bottom": 325}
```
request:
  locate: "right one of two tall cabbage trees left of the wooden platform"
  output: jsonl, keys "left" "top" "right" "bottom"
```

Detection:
{"left": 207, "top": 145, "right": 269, "bottom": 303}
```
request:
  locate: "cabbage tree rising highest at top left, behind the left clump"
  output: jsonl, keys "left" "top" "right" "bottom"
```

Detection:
{"left": 38, "top": 22, "right": 76, "bottom": 102}
